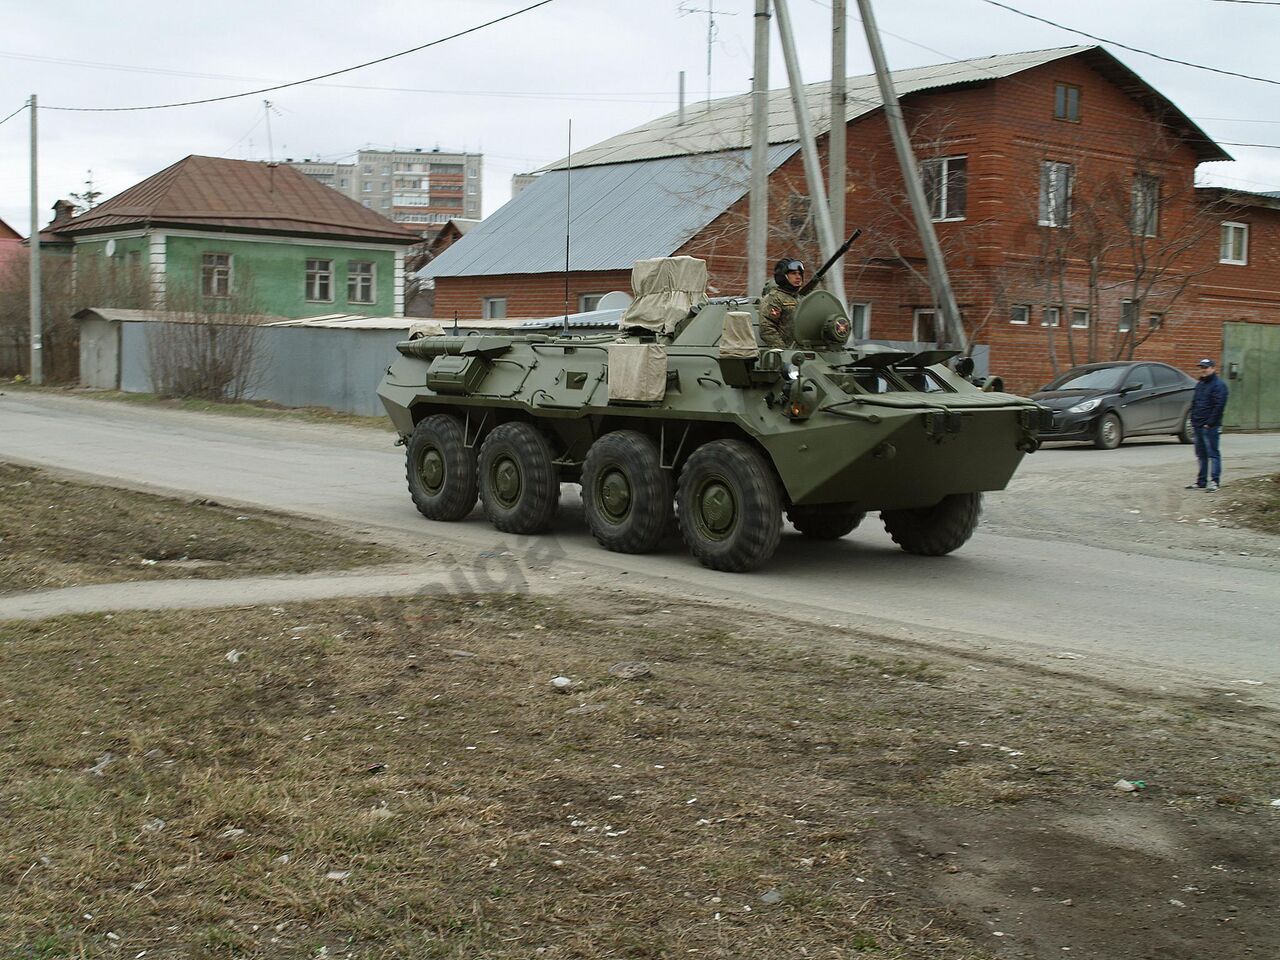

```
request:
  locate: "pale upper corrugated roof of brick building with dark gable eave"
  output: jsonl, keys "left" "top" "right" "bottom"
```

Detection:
{"left": 541, "top": 46, "right": 1230, "bottom": 170}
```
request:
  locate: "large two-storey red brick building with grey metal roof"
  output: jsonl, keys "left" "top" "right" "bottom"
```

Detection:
{"left": 425, "top": 46, "right": 1280, "bottom": 414}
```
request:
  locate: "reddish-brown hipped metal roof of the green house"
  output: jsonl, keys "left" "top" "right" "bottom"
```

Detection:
{"left": 60, "top": 156, "right": 419, "bottom": 244}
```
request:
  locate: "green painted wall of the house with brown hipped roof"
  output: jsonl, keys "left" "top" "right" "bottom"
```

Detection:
{"left": 165, "top": 234, "right": 396, "bottom": 317}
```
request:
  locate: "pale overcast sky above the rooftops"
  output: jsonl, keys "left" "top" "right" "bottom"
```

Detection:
{"left": 0, "top": 0, "right": 1280, "bottom": 234}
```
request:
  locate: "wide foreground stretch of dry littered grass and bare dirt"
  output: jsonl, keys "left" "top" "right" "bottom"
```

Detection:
{"left": 0, "top": 599, "right": 1280, "bottom": 960}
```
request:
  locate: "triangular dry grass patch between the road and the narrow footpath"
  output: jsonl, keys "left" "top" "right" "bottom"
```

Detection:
{"left": 0, "top": 463, "right": 397, "bottom": 593}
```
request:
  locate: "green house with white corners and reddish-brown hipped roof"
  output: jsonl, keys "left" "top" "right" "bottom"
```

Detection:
{"left": 52, "top": 156, "right": 419, "bottom": 317}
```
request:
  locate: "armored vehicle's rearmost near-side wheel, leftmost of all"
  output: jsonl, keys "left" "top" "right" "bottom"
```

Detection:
{"left": 404, "top": 413, "right": 476, "bottom": 520}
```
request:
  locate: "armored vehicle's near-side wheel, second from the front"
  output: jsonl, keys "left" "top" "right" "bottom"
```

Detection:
{"left": 582, "top": 430, "right": 671, "bottom": 553}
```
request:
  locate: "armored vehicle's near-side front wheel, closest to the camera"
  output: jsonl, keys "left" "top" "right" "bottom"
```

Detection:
{"left": 676, "top": 440, "right": 782, "bottom": 573}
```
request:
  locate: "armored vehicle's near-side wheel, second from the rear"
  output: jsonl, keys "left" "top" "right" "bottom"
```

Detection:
{"left": 479, "top": 422, "right": 559, "bottom": 534}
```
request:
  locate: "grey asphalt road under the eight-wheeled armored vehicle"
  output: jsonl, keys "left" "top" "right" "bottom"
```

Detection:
{"left": 0, "top": 390, "right": 1280, "bottom": 703}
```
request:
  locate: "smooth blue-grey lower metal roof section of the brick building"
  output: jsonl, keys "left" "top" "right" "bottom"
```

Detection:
{"left": 419, "top": 143, "right": 799, "bottom": 279}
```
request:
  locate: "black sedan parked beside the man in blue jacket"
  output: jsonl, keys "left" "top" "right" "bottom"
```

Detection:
{"left": 1032, "top": 361, "right": 1196, "bottom": 451}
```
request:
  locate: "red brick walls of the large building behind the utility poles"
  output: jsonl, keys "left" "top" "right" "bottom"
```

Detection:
{"left": 436, "top": 55, "right": 1280, "bottom": 392}
